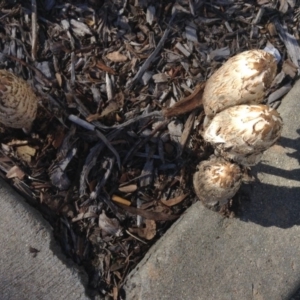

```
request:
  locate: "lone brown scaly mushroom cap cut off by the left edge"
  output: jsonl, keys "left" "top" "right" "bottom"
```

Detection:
{"left": 0, "top": 70, "right": 38, "bottom": 131}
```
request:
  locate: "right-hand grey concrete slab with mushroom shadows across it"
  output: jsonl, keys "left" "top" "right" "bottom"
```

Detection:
{"left": 125, "top": 81, "right": 300, "bottom": 300}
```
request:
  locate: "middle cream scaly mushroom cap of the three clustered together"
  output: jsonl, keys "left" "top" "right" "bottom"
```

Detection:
{"left": 203, "top": 104, "right": 283, "bottom": 166}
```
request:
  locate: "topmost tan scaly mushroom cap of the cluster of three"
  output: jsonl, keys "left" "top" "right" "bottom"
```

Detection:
{"left": 203, "top": 50, "right": 277, "bottom": 118}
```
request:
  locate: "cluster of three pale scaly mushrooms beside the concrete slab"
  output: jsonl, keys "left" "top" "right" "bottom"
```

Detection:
{"left": 193, "top": 50, "right": 283, "bottom": 208}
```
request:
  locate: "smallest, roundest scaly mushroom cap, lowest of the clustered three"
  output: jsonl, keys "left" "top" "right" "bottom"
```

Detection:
{"left": 193, "top": 157, "right": 242, "bottom": 207}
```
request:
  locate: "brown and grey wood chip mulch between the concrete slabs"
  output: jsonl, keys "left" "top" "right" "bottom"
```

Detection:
{"left": 0, "top": 0, "right": 300, "bottom": 299}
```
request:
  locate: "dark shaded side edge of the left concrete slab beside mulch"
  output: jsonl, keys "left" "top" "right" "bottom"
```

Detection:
{"left": 0, "top": 178, "right": 91, "bottom": 298}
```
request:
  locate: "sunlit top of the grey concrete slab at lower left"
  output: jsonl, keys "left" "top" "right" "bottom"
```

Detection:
{"left": 0, "top": 179, "right": 89, "bottom": 300}
